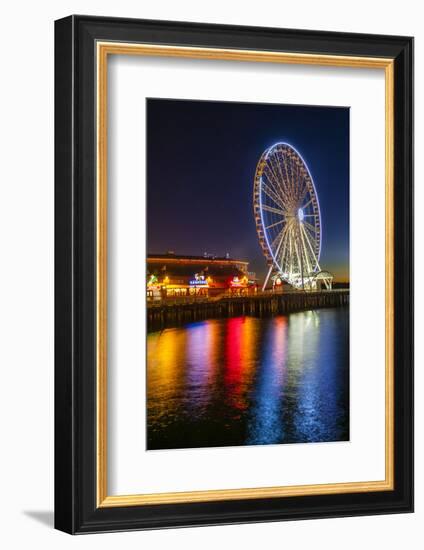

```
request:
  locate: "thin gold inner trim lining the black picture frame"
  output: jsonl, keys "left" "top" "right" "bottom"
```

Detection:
{"left": 96, "top": 41, "right": 394, "bottom": 508}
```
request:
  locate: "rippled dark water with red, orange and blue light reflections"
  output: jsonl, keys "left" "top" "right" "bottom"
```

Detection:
{"left": 147, "top": 308, "right": 349, "bottom": 449}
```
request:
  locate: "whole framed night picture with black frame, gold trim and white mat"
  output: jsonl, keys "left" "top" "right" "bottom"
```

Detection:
{"left": 55, "top": 16, "right": 413, "bottom": 534}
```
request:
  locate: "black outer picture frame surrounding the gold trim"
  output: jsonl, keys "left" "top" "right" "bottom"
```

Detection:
{"left": 55, "top": 15, "right": 413, "bottom": 534}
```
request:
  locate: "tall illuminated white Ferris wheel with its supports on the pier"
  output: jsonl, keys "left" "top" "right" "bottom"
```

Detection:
{"left": 253, "top": 143, "right": 333, "bottom": 290}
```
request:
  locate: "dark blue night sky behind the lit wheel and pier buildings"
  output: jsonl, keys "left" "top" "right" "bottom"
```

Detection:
{"left": 147, "top": 99, "right": 349, "bottom": 281}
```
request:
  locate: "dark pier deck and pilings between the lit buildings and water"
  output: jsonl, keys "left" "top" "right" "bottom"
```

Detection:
{"left": 147, "top": 289, "right": 349, "bottom": 332}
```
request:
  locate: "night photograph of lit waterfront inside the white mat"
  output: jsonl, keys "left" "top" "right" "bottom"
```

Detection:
{"left": 146, "top": 98, "right": 350, "bottom": 451}
